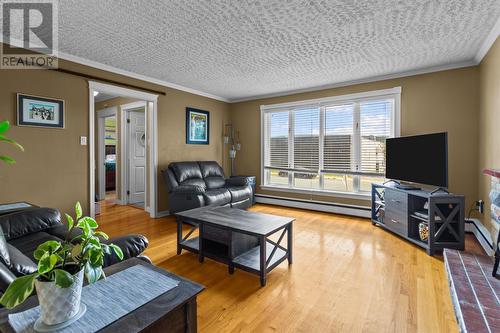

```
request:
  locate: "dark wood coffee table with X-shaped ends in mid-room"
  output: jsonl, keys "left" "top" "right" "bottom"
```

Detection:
{"left": 175, "top": 206, "right": 295, "bottom": 286}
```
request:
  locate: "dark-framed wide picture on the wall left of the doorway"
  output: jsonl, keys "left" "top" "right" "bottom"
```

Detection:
{"left": 17, "top": 94, "right": 64, "bottom": 128}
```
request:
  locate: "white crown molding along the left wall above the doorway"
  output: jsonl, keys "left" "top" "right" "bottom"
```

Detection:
{"left": 57, "top": 51, "right": 229, "bottom": 103}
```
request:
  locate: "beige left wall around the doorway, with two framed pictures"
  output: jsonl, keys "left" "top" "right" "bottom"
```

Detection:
{"left": 0, "top": 56, "right": 229, "bottom": 212}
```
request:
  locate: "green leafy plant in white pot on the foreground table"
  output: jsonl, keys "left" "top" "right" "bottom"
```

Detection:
{"left": 0, "top": 202, "right": 123, "bottom": 325}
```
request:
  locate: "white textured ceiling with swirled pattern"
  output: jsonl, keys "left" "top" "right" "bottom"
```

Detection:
{"left": 59, "top": 0, "right": 500, "bottom": 100}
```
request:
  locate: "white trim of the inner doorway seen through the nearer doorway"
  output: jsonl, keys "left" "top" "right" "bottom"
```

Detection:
{"left": 120, "top": 101, "right": 147, "bottom": 210}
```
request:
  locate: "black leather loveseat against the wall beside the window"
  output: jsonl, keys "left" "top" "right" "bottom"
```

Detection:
{"left": 162, "top": 161, "right": 253, "bottom": 214}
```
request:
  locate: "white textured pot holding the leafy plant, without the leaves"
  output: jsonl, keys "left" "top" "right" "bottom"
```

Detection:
{"left": 35, "top": 269, "right": 83, "bottom": 325}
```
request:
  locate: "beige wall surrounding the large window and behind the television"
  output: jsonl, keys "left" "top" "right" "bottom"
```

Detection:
{"left": 231, "top": 67, "right": 479, "bottom": 205}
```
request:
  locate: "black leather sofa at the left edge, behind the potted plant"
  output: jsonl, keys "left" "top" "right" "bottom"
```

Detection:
{"left": 0, "top": 208, "right": 151, "bottom": 293}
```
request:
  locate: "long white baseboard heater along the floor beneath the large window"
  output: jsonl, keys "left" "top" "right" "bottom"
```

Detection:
{"left": 255, "top": 194, "right": 371, "bottom": 218}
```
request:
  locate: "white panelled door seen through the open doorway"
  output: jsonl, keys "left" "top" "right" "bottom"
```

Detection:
{"left": 127, "top": 111, "right": 146, "bottom": 204}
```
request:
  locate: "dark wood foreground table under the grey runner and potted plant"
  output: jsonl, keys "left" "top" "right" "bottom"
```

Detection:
{"left": 0, "top": 258, "right": 205, "bottom": 333}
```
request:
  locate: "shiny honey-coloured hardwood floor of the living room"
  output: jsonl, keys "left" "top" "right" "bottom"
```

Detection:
{"left": 94, "top": 204, "right": 468, "bottom": 333}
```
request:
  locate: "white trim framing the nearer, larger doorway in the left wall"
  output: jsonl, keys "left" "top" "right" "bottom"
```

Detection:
{"left": 88, "top": 81, "right": 158, "bottom": 218}
